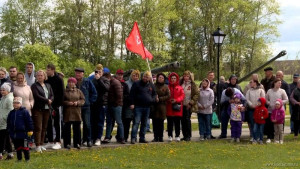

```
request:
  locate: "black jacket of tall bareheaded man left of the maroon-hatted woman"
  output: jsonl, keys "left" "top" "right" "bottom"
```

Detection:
{"left": 45, "top": 72, "right": 65, "bottom": 108}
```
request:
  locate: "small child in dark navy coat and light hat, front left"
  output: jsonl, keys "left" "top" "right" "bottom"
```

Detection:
{"left": 7, "top": 97, "right": 33, "bottom": 161}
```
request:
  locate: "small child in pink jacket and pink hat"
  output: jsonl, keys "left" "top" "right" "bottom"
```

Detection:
{"left": 271, "top": 99, "right": 285, "bottom": 144}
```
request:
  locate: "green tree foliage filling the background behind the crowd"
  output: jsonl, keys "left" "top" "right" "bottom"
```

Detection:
{"left": 0, "top": 0, "right": 280, "bottom": 79}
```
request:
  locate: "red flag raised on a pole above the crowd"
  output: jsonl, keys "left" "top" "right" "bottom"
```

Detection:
{"left": 125, "top": 22, "right": 147, "bottom": 59}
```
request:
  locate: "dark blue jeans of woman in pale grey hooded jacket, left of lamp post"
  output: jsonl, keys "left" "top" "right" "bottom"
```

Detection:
{"left": 197, "top": 113, "right": 212, "bottom": 138}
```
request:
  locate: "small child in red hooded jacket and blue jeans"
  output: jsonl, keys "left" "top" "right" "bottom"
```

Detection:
{"left": 252, "top": 97, "right": 269, "bottom": 144}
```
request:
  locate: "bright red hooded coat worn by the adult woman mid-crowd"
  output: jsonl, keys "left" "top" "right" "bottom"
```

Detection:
{"left": 167, "top": 72, "right": 184, "bottom": 117}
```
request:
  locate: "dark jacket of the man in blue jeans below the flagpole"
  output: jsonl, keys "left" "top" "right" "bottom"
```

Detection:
{"left": 130, "top": 80, "right": 156, "bottom": 107}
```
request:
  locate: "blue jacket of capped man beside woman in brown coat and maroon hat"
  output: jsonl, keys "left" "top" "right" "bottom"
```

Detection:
{"left": 79, "top": 78, "right": 98, "bottom": 107}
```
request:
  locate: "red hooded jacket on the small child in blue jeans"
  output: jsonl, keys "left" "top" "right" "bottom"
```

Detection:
{"left": 253, "top": 97, "right": 269, "bottom": 124}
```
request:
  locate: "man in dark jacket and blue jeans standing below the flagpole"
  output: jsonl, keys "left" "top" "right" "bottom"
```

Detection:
{"left": 130, "top": 71, "right": 156, "bottom": 144}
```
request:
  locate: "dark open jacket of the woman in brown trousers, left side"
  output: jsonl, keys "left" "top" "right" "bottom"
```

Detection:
{"left": 31, "top": 82, "right": 54, "bottom": 110}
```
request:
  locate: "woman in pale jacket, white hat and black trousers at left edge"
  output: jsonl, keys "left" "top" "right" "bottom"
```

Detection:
{"left": 0, "top": 83, "right": 14, "bottom": 160}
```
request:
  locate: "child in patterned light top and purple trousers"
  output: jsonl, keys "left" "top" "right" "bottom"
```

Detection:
{"left": 228, "top": 93, "right": 245, "bottom": 142}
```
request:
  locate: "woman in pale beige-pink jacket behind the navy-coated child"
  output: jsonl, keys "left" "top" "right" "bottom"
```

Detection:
{"left": 14, "top": 72, "right": 34, "bottom": 116}
